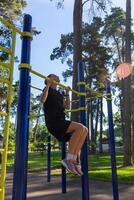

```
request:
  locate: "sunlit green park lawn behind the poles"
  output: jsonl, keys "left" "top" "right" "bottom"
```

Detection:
{"left": 7, "top": 152, "right": 134, "bottom": 184}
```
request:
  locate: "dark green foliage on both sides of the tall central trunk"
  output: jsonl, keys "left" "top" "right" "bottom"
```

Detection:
{"left": 50, "top": 17, "right": 111, "bottom": 83}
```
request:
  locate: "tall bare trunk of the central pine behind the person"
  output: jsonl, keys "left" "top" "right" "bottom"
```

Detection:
{"left": 72, "top": 0, "right": 82, "bottom": 121}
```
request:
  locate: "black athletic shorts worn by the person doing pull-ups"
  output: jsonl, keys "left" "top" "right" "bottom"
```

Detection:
{"left": 46, "top": 119, "right": 71, "bottom": 142}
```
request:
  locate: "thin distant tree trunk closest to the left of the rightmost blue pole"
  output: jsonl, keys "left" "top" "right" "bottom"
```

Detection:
{"left": 99, "top": 98, "right": 103, "bottom": 154}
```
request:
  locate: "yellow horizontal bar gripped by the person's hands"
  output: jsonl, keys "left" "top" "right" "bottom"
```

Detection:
{"left": 30, "top": 69, "right": 86, "bottom": 96}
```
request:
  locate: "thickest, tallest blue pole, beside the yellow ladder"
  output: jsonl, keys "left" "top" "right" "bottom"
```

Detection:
{"left": 12, "top": 15, "right": 32, "bottom": 200}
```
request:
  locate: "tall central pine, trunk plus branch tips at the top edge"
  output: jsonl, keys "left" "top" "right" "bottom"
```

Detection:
{"left": 51, "top": 0, "right": 108, "bottom": 121}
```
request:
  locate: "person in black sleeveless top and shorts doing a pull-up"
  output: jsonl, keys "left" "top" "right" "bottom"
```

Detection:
{"left": 40, "top": 74, "right": 88, "bottom": 176}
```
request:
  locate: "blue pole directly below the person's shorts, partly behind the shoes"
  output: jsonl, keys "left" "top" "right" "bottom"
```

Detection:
{"left": 61, "top": 142, "right": 67, "bottom": 193}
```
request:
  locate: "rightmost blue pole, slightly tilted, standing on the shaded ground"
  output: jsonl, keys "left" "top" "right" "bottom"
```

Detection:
{"left": 106, "top": 81, "right": 119, "bottom": 200}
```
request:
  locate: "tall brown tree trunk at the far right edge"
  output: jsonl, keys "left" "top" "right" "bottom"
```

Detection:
{"left": 123, "top": 0, "right": 132, "bottom": 166}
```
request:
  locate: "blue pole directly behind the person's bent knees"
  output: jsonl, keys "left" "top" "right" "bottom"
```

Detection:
{"left": 78, "top": 61, "right": 89, "bottom": 200}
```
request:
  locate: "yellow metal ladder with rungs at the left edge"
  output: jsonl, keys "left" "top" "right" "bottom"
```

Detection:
{"left": 0, "top": 29, "right": 16, "bottom": 200}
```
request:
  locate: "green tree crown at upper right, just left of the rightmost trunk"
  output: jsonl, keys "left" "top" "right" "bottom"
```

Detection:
{"left": 103, "top": 7, "right": 126, "bottom": 63}
